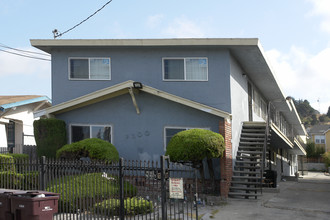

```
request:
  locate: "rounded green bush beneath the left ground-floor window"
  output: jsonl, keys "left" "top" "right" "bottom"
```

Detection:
{"left": 56, "top": 138, "right": 119, "bottom": 162}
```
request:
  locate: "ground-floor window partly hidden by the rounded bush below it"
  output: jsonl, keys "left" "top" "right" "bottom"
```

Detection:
{"left": 71, "top": 125, "right": 111, "bottom": 143}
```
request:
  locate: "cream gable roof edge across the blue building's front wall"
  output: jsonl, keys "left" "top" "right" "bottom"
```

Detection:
{"left": 35, "top": 80, "right": 231, "bottom": 119}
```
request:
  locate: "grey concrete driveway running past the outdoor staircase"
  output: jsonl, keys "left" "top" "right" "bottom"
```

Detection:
{"left": 199, "top": 172, "right": 330, "bottom": 220}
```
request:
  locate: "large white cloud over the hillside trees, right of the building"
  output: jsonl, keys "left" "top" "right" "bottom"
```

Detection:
{"left": 266, "top": 47, "right": 330, "bottom": 113}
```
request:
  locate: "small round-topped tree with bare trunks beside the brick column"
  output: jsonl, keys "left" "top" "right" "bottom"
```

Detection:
{"left": 166, "top": 129, "right": 225, "bottom": 180}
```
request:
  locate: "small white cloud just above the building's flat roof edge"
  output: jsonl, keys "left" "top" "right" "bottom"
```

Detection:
{"left": 162, "top": 16, "right": 205, "bottom": 38}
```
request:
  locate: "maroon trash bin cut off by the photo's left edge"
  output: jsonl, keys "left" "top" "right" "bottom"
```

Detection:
{"left": 0, "top": 189, "right": 26, "bottom": 220}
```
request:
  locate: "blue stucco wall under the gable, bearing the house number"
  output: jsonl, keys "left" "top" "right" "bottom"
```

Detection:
{"left": 56, "top": 92, "right": 220, "bottom": 163}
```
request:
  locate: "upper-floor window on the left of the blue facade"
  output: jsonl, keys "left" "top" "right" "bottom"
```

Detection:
{"left": 69, "top": 58, "right": 111, "bottom": 80}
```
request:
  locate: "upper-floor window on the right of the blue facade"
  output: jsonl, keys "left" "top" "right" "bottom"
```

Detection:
{"left": 163, "top": 58, "right": 208, "bottom": 81}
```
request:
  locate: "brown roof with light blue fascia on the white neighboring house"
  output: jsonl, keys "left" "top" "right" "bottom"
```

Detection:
{"left": 0, "top": 95, "right": 51, "bottom": 111}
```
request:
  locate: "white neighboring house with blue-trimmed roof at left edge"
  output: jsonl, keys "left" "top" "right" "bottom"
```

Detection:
{"left": 0, "top": 95, "right": 51, "bottom": 153}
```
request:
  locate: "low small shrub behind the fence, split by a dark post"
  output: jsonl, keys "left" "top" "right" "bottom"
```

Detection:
{"left": 94, "top": 197, "right": 154, "bottom": 216}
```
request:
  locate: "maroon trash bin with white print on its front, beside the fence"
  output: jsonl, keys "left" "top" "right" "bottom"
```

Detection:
{"left": 11, "top": 191, "right": 59, "bottom": 220}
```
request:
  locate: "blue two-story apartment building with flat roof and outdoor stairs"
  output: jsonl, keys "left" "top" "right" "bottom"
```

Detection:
{"left": 31, "top": 38, "right": 306, "bottom": 196}
